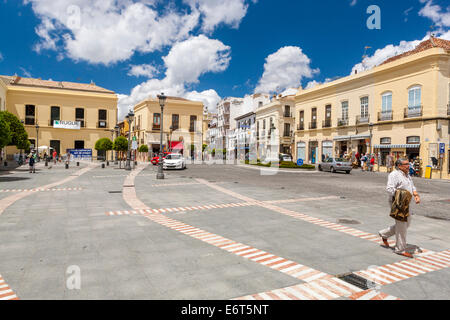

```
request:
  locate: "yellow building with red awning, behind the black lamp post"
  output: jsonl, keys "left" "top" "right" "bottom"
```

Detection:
{"left": 132, "top": 97, "right": 204, "bottom": 159}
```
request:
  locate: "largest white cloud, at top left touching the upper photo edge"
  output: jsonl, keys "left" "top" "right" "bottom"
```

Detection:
{"left": 24, "top": 0, "right": 200, "bottom": 65}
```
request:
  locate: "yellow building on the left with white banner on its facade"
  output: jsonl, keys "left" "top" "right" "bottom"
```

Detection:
{"left": 0, "top": 76, "right": 118, "bottom": 158}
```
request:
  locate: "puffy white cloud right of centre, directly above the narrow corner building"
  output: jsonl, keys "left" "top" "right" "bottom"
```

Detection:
{"left": 255, "top": 46, "right": 319, "bottom": 93}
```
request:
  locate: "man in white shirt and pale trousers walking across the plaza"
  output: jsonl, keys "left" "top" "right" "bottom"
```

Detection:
{"left": 378, "top": 158, "right": 420, "bottom": 258}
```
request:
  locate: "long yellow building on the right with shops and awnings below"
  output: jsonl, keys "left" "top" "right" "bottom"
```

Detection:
{"left": 295, "top": 38, "right": 450, "bottom": 179}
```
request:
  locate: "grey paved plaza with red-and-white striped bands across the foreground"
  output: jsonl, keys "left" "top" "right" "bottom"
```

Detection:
{"left": 0, "top": 163, "right": 450, "bottom": 300}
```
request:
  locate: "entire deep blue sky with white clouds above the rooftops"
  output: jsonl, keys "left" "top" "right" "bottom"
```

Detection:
{"left": 0, "top": 0, "right": 450, "bottom": 117}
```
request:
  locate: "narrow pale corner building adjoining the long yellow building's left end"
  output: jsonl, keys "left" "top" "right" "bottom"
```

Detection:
{"left": 256, "top": 95, "right": 295, "bottom": 158}
